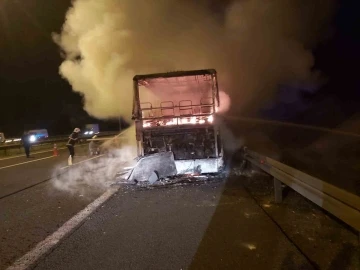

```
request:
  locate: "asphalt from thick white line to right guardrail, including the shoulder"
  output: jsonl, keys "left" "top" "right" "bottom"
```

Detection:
{"left": 29, "top": 176, "right": 359, "bottom": 270}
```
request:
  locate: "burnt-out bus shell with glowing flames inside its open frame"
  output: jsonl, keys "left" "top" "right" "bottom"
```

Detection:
{"left": 133, "top": 69, "right": 223, "bottom": 174}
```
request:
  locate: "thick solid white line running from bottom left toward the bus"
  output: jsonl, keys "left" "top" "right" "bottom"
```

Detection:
{"left": 7, "top": 187, "right": 120, "bottom": 270}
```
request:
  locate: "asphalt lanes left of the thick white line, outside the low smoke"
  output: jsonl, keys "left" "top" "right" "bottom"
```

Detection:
{"left": 0, "top": 146, "right": 102, "bottom": 269}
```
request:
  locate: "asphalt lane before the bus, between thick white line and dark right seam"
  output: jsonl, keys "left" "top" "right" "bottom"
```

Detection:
{"left": 35, "top": 179, "right": 313, "bottom": 269}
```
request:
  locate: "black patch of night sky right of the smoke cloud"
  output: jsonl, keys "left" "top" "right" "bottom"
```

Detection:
{"left": 262, "top": 0, "right": 360, "bottom": 129}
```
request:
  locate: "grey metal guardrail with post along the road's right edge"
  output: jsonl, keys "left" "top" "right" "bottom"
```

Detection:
{"left": 245, "top": 149, "right": 360, "bottom": 232}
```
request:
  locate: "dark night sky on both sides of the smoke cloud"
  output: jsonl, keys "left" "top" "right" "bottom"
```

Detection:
{"left": 0, "top": 0, "right": 360, "bottom": 136}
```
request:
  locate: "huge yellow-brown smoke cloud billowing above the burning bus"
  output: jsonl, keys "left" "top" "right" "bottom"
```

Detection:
{"left": 54, "top": 0, "right": 332, "bottom": 119}
